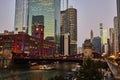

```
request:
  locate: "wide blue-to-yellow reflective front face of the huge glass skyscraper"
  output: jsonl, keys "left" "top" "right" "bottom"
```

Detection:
{"left": 28, "top": 0, "right": 60, "bottom": 39}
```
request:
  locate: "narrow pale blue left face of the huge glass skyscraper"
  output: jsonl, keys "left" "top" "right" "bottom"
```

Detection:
{"left": 14, "top": 0, "right": 28, "bottom": 34}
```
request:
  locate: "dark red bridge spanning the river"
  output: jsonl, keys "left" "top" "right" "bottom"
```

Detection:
{"left": 12, "top": 52, "right": 103, "bottom": 67}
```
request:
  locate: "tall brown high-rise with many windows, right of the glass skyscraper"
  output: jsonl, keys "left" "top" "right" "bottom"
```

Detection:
{"left": 60, "top": 7, "right": 77, "bottom": 55}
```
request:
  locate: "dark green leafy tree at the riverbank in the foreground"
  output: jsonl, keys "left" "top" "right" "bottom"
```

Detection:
{"left": 77, "top": 58, "right": 102, "bottom": 80}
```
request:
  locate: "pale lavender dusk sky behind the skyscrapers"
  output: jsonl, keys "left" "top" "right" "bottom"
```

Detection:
{"left": 0, "top": 0, "right": 117, "bottom": 46}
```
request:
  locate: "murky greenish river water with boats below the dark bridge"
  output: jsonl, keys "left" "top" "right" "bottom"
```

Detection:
{"left": 0, "top": 63, "right": 76, "bottom": 80}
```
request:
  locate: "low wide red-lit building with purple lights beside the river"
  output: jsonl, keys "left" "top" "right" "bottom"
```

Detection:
{"left": 0, "top": 27, "right": 55, "bottom": 58}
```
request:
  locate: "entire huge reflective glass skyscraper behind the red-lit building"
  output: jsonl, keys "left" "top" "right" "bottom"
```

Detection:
{"left": 15, "top": 0, "right": 60, "bottom": 53}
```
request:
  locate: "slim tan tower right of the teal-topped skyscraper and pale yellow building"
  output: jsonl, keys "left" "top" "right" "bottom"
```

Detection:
{"left": 109, "top": 28, "right": 114, "bottom": 54}
